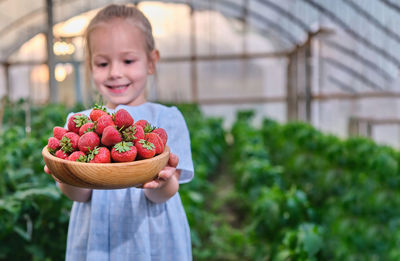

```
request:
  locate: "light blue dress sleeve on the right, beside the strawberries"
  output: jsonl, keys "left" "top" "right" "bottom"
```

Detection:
{"left": 160, "top": 106, "right": 194, "bottom": 183}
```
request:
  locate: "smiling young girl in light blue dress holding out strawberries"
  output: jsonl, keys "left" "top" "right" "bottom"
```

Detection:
{"left": 45, "top": 5, "right": 193, "bottom": 261}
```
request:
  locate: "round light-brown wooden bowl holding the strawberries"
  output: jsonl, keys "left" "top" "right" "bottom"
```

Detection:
{"left": 42, "top": 146, "right": 170, "bottom": 189}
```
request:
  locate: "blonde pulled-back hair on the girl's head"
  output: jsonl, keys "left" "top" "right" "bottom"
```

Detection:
{"left": 85, "top": 4, "right": 155, "bottom": 72}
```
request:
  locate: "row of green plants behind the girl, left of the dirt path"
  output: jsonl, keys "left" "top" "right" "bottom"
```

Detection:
{"left": 0, "top": 101, "right": 225, "bottom": 260}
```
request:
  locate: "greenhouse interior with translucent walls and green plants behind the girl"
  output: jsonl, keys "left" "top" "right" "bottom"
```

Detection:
{"left": 0, "top": 0, "right": 400, "bottom": 261}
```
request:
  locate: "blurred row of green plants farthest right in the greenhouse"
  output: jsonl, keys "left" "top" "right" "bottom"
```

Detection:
{"left": 261, "top": 119, "right": 400, "bottom": 260}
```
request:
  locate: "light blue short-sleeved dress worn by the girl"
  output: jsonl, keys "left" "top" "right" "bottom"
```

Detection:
{"left": 66, "top": 103, "right": 193, "bottom": 261}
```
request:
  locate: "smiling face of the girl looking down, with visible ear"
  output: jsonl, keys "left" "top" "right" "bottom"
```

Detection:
{"left": 89, "top": 19, "right": 158, "bottom": 108}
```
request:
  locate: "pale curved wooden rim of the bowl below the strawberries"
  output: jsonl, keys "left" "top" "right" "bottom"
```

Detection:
{"left": 42, "top": 145, "right": 170, "bottom": 167}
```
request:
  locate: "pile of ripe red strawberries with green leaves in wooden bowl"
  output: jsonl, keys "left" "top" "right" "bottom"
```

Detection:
{"left": 47, "top": 106, "right": 168, "bottom": 163}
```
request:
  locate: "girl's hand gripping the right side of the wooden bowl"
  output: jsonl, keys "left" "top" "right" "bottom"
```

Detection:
{"left": 143, "top": 153, "right": 180, "bottom": 189}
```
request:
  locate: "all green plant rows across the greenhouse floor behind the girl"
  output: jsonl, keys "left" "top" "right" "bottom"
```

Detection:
{"left": 0, "top": 102, "right": 400, "bottom": 260}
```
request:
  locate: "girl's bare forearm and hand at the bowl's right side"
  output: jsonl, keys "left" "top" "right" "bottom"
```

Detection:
{"left": 143, "top": 153, "right": 180, "bottom": 203}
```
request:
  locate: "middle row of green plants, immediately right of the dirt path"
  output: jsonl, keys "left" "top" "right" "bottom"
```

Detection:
{"left": 227, "top": 111, "right": 324, "bottom": 260}
